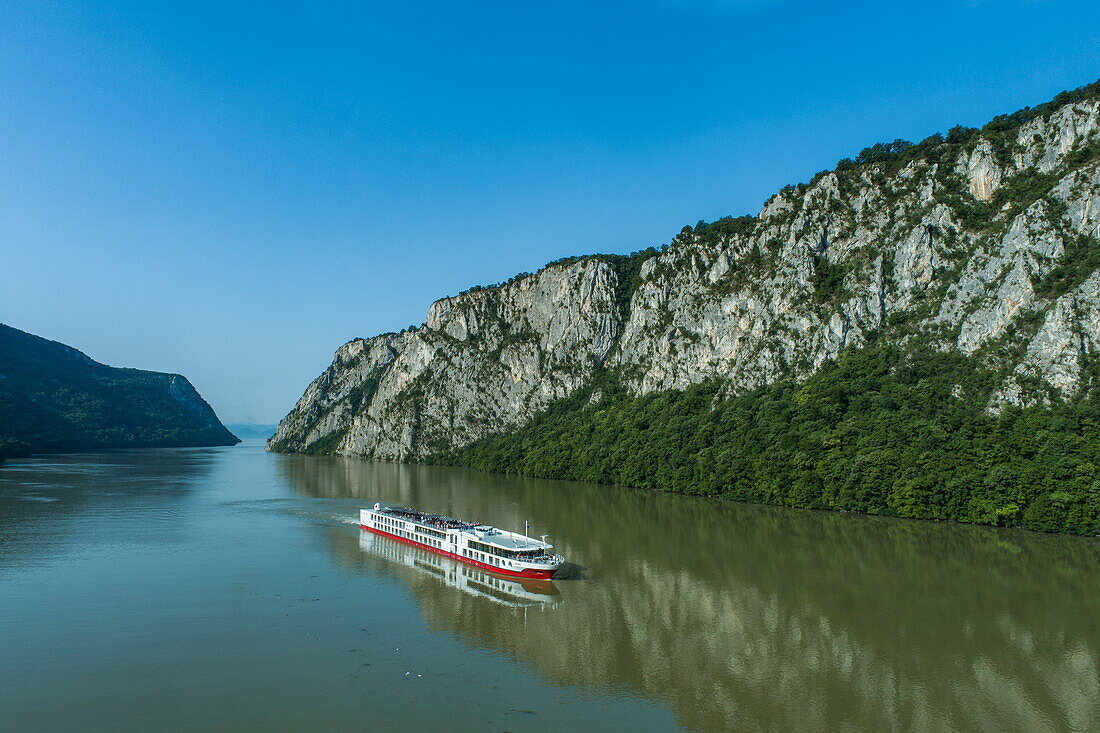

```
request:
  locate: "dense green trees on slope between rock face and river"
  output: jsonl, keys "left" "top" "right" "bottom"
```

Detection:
{"left": 431, "top": 347, "right": 1100, "bottom": 534}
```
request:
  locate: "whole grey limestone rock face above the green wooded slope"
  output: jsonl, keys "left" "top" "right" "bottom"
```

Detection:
{"left": 270, "top": 89, "right": 1100, "bottom": 460}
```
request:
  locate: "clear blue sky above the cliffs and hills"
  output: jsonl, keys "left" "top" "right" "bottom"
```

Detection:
{"left": 0, "top": 0, "right": 1100, "bottom": 423}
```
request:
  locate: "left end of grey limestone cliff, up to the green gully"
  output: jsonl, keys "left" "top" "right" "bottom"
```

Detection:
{"left": 271, "top": 260, "right": 620, "bottom": 459}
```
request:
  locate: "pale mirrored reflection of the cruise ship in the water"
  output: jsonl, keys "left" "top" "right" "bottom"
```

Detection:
{"left": 359, "top": 530, "right": 561, "bottom": 609}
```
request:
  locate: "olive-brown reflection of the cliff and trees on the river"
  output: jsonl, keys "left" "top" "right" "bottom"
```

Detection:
{"left": 277, "top": 456, "right": 1100, "bottom": 731}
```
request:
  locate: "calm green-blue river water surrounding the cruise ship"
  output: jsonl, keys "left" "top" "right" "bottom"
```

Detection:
{"left": 0, "top": 442, "right": 1100, "bottom": 731}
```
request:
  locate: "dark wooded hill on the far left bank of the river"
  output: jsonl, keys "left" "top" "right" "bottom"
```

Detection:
{"left": 0, "top": 324, "right": 240, "bottom": 457}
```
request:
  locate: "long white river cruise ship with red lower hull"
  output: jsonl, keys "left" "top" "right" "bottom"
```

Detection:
{"left": 359, "top": 502, "right": 565, "bottom": 578}
